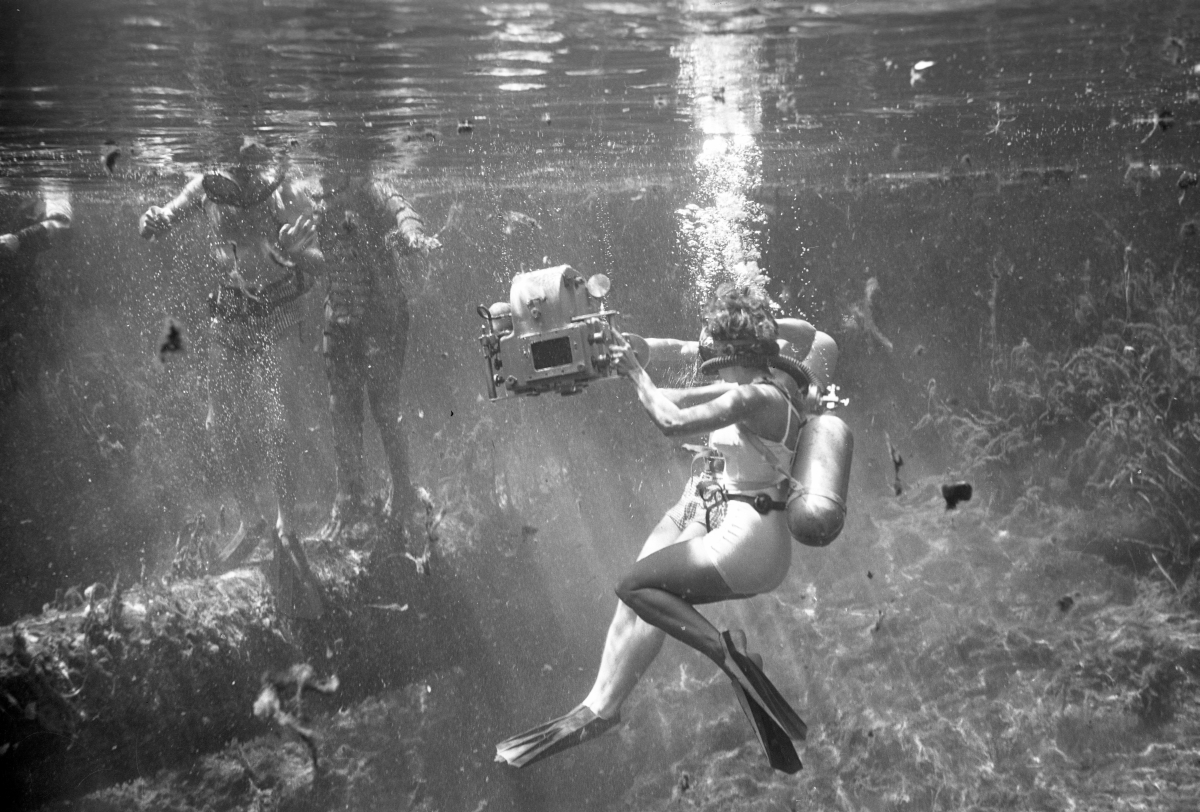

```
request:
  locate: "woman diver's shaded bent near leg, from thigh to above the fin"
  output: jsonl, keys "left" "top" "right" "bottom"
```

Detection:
{"left": 617, "top": 539, "right": 746, "bottom": 666}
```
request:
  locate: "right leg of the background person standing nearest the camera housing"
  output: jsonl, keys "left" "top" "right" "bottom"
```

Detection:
{"left": 364, "top": 295, "right": 416, "bottom": 521}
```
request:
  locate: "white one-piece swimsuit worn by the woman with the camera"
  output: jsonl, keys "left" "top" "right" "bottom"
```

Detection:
{"left": 672, "top": 381, "right": 805, "bottom": 595}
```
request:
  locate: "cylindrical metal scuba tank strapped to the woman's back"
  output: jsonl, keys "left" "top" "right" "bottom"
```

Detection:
{"left": 787, "top": 332, "right": 854, "bottom": 547}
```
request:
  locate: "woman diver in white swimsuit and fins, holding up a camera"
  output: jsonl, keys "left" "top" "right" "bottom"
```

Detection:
{"left": 496, "top": 279, "right": 848, "bottom": 772}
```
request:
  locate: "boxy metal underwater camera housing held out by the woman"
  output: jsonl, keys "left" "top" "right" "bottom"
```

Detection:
{"left": 479, "top": 265, "right": 646, "bottom": 401}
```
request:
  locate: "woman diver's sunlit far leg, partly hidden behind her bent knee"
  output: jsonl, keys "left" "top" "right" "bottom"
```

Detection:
{"left": 583, "top": 516, "right": 704, "bottom": 718}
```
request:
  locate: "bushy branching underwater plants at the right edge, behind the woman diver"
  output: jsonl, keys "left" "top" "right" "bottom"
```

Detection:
{"left": 914, "top": 251, "right": 1200, "bottom": 585}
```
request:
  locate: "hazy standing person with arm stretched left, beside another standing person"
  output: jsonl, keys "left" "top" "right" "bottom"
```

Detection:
{"left": 138, "top": 142, "right": 319, "bottom": 614}
